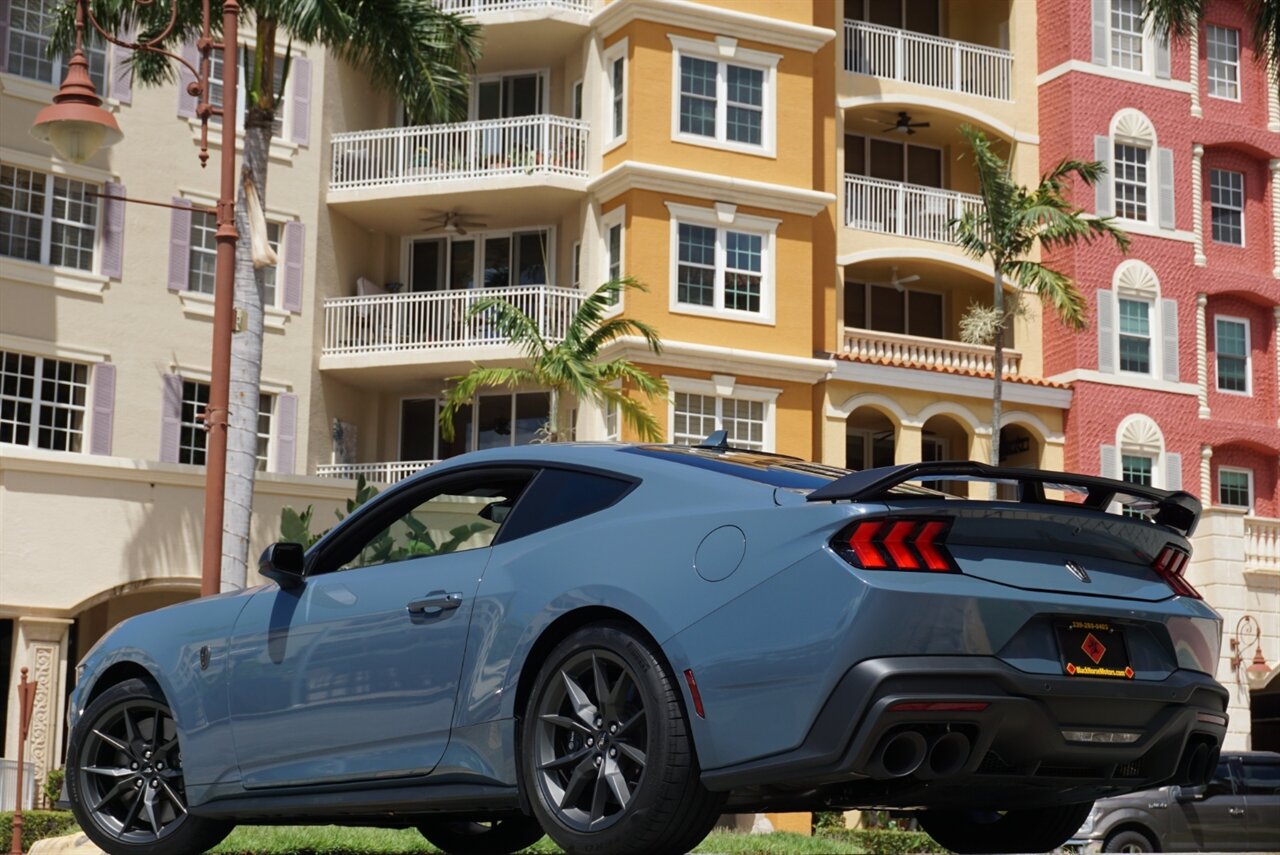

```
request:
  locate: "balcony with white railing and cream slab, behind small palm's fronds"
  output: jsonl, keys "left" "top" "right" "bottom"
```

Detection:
{"left": 320, "top": 285, "right": 586, "bottom": 371}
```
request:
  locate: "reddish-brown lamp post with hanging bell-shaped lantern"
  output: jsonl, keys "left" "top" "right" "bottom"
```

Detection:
{"left": 31, "top": 0, "right": 241, "bottom": 596}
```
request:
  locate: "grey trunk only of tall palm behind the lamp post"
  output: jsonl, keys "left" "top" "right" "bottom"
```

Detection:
{"left": 221, "top": 115, "right": 272, "bottom": 591}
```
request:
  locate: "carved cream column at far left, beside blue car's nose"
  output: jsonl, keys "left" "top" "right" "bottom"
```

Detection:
{"left": 4, "top": 617, "right": 72, "bottom": 794}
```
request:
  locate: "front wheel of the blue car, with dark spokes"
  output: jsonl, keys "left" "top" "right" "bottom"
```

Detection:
{"left": 67, "top": 680, "right": 234, "bottom": 855}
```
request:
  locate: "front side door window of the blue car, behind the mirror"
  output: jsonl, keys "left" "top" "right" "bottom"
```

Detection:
{"left": 315, "top": 472, "right": 530, "bottom": 573}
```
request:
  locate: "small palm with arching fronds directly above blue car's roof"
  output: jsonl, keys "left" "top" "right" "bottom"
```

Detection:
{"left": 440, "top": 276, "right": 667, "bottom": 442}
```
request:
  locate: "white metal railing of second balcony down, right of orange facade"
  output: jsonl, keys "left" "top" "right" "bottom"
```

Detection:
{"left": 845, "top": 175, "right": 982, "bottom": 243}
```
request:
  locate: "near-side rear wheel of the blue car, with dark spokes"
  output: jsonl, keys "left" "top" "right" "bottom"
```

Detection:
{"left": 521, "top": 623, "right": 724, "bottom": 855}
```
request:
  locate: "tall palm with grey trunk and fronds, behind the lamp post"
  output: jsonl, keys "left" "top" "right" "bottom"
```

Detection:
{"left": 50, "top": 0, "right": 480, "bottom": 590}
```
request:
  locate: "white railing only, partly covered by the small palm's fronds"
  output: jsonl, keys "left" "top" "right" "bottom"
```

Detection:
{"left": 323, "top": 285, "right": 586, "bottom": 356}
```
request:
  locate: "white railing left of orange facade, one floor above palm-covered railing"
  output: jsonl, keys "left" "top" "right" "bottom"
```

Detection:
{"left": 329, "top": 115, "right": 588, "bottom": 189}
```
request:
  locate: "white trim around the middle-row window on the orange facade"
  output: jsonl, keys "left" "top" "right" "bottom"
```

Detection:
{"left": 666, "top": 202, "right": 782, "bottom": 326}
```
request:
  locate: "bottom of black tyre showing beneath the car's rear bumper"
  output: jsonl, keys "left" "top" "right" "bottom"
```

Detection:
{"left": 919, "top": 801, "right": 1093, "bottom": 852}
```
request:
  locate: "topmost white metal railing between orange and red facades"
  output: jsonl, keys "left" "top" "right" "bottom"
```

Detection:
{"left": 845, "top": 20, "right": 1014, "bottom": 101}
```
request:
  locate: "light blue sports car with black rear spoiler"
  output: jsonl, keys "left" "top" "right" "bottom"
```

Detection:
{"left": 67, "top": 435, "right": 1228, "bottom": 855}
